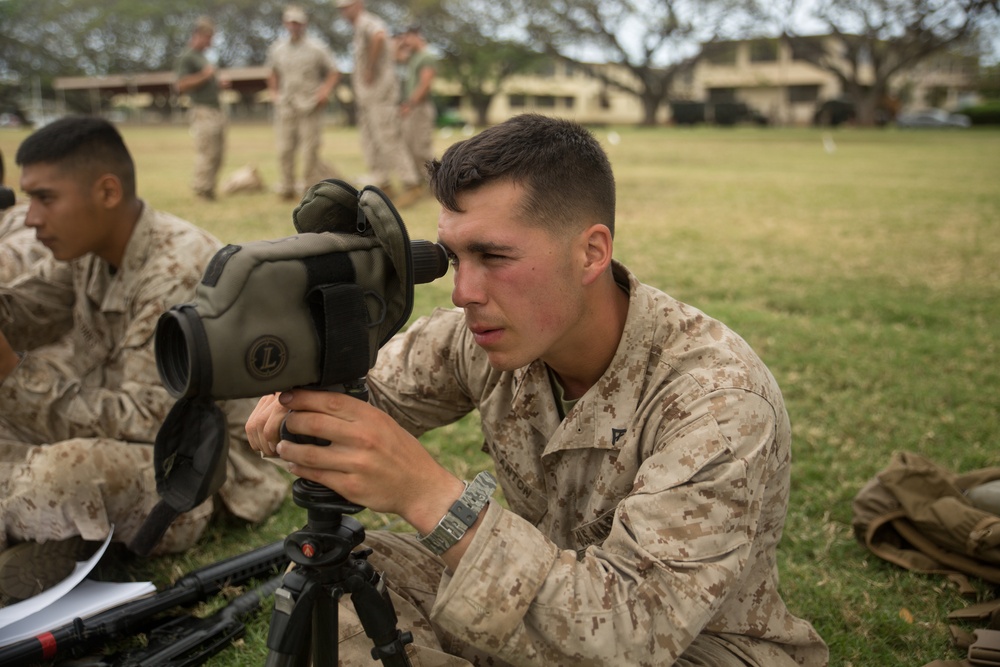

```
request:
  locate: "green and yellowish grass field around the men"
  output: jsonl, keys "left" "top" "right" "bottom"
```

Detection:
{"left": 0, "top": 121, "right": 1000, "bottom": 667}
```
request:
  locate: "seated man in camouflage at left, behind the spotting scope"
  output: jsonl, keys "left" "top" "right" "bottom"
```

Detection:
{"left": 0, "top": 117, "right": 287, "bottom": 599}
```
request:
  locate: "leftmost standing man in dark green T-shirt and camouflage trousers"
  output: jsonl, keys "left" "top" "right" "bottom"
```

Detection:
{"left": 175, "top": 16, "right": 226, "bottom": 201}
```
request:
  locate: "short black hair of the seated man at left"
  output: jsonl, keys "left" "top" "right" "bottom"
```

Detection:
{"left": 14, "top": 116, "right": 136, "bottom": 198}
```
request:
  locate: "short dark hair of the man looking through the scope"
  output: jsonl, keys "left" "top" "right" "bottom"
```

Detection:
{"left": 427, "top": 114, "right": 615, "bottom": 235}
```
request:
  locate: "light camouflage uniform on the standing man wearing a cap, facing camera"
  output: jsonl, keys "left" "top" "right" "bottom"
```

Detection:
{"left": 267, "top": 35, "right": 337, "bottom": 194}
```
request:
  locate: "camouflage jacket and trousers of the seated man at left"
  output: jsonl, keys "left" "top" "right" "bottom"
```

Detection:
{"left": 0, "top": 206, "right": 286, "bottom": 552}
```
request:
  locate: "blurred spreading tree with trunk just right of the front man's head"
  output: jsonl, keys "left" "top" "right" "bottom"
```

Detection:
{"left": 526, "top": 0, "right": 744, "bottom": 125}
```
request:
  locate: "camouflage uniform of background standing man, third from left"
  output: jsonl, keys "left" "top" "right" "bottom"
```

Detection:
{"left": 351, "top": 11, "right": 422, "bottom": 187}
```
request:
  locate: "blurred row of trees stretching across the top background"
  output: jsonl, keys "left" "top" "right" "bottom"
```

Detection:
{"left": 0, "top": 0, "right": 1000, "bottom": 124}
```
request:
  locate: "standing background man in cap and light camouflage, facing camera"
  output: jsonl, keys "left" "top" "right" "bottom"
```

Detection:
{"left": 267, "top": 5, "right": 340, "bottom": 199}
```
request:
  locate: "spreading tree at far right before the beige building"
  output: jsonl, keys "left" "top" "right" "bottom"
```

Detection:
{"left": 782, "top": 0, "right": 998, "bottom": 126}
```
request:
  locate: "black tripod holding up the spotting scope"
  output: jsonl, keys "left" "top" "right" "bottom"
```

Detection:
{"left": 266, "top": 390, "right": 413, "bottom": 667}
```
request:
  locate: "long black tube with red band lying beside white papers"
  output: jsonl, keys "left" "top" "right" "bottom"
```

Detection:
{"left": 0, "top": 541, "right": 289, "bottom": 667}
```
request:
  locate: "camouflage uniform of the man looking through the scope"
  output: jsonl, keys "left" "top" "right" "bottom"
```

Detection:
{"left": 341, "top": 264, "right": 828, "bottom": 667}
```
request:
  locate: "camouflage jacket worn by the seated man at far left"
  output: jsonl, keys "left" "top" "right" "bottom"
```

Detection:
{"left": 0, "top": 206, "right": 287, "bottom": 521}
